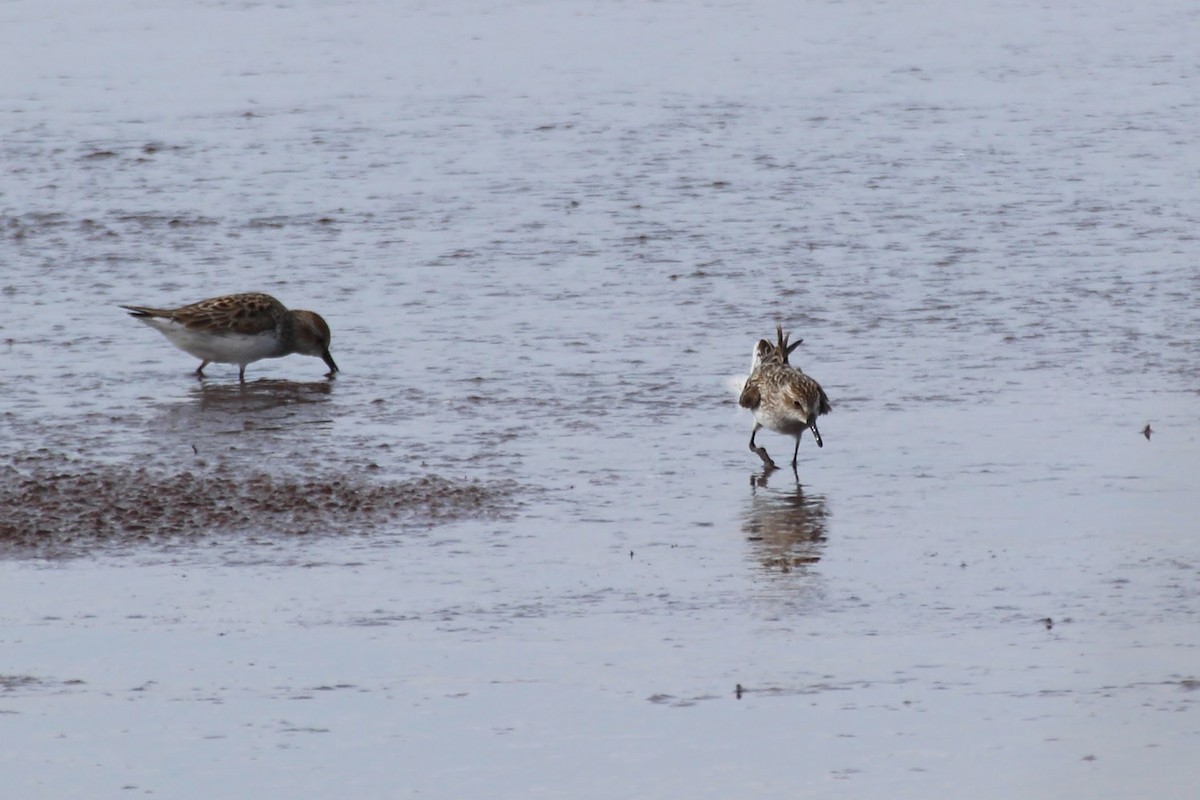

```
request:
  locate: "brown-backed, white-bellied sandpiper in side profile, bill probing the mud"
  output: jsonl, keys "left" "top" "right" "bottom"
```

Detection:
{"left": 121, "top": 291, "right": 337, "bottom": 383}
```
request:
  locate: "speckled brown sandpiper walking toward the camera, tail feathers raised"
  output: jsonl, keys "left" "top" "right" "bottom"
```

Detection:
{"left": 738, "top": 325, "right": 832, "bottom": 469}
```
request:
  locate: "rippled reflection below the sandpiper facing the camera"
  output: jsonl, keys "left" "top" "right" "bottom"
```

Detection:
{"left": 743, "top": 469, "right": 829, "bottom": 572}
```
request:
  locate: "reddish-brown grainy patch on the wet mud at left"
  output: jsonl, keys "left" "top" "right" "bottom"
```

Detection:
{"left": 0, "top": 456, "right": 514, "bottom": 558}
